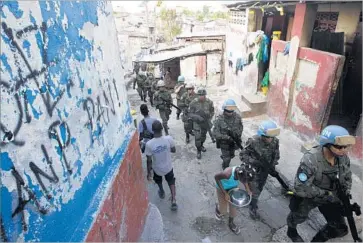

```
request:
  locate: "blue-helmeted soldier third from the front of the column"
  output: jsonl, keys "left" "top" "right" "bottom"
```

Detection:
{"left": 213, "top": 99, "right": 243, "bottom": 170}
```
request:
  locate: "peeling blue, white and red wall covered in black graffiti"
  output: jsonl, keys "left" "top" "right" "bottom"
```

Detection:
{"left": 0, "top": 1, "right": 148, "bottom": 242}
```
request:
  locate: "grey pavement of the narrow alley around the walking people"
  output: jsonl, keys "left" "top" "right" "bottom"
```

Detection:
{"left": 128, "top": 87, "right": 362, "bottom": 242}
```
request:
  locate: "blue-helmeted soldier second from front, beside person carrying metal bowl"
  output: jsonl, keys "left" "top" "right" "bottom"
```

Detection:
{"left": 240, "top": 121, "right": 280, "bottom": 220}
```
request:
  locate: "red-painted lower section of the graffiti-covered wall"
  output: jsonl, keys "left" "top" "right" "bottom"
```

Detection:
{"left": 86, "top": 132, "right": 149, "bottom": 242}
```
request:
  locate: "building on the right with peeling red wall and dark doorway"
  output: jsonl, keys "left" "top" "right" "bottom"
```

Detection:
{"left": 227, "top": 1, "right": 362, "bottom": 158}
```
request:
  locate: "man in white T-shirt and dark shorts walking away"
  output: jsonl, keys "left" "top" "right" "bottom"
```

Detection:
{"left": 145, "top": 120, "right": 178, "bottom": 211}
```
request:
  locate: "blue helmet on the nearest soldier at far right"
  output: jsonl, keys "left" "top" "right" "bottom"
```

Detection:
{"left": 319, "top": 125, "right": 355, "bottom": 146}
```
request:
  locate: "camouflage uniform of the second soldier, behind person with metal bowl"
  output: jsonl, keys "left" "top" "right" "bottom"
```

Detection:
{"left": 239, "top": 135, "right": 280, "bottom": 213}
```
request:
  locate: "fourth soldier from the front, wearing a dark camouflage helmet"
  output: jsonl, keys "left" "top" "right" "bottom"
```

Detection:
{"left": 188, "top": 89, "right": 214, "bottom": 159}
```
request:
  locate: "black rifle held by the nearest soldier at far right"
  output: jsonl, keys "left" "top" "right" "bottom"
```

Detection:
{"left": 335, "top": 174, "right": 362, "bottom": 242}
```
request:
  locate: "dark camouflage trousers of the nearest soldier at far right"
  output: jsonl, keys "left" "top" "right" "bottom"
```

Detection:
{"left": 287, "top": 196, "right": 346, "bottom": 229}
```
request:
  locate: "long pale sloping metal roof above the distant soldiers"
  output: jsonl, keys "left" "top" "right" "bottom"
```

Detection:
{"left": 138, "top": 43, "right": 222, "bottom": 63}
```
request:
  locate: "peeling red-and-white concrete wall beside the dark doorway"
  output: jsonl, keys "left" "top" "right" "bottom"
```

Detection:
{"left": 268, "top": 41, "right": 345, "bottom": 138}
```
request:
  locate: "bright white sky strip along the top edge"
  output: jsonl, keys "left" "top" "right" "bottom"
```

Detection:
{"left": 112, "top": 1, "right": 241, "bottom": 13}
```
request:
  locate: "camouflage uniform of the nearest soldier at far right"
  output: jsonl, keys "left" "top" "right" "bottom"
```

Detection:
{"left": 287, "top": 146, "right": 352, "bottom": 238}
